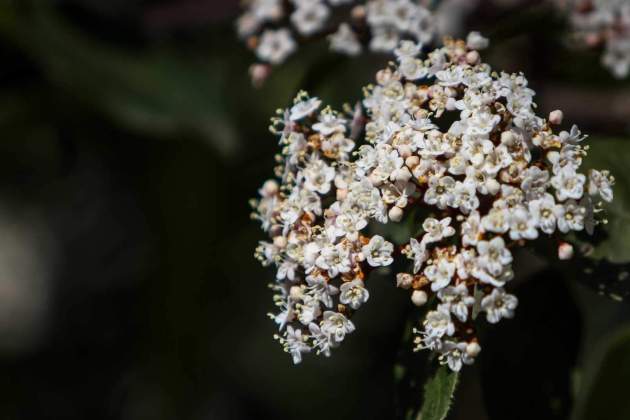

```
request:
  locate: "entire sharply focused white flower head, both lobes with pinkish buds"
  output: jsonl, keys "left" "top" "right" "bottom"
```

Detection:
{"left": 256, "top": 34, "right": 614, "bottom": 371}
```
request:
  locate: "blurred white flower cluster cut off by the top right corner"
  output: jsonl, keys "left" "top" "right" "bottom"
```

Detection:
{"left": 555, "top": 0, "right": 630, "bottom": 79}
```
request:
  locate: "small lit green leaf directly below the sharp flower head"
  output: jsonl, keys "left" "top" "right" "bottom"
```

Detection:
{"left": 416, "top": 366, "right": 459, "bottom": 420}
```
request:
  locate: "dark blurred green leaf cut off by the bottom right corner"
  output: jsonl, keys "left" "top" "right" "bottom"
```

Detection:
{"left": 574, "top": 327, "right": 630, "bottom": 420}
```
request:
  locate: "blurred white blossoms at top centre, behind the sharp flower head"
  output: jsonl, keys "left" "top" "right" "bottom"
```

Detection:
{"left": 237, "top": 0, "right": 476, "bottom": 84}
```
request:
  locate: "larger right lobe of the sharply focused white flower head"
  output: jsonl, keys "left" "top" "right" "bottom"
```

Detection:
{"left": 356, "top": 34, "right": 613, "bottom": 370}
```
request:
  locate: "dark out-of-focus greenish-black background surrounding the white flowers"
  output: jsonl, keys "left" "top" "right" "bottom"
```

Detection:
{"left": 0, "top": 0, "right": 630, "bottom": 420}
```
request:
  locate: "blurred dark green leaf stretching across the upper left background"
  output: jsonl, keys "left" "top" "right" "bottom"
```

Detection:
{"left": 0, "top": 1, "right": 242, "bottom": 156}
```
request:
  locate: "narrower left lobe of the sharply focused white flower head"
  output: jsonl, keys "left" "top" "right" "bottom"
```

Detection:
{"left": 252, "top": 93, "right": 394, "bottom": 363}
